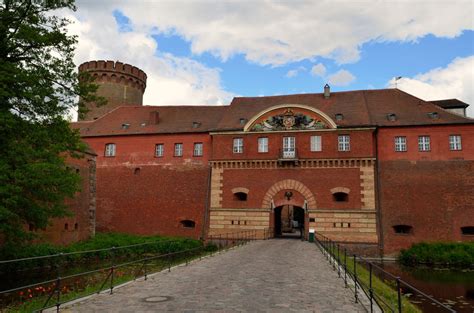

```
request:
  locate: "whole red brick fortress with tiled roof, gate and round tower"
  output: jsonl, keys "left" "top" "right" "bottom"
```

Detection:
{"left": 73, "top": 61, "right": 474, "bottom": 254}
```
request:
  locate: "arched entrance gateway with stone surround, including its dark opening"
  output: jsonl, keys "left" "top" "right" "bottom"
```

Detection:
{"left": 262, "top": 179, "right": 316, "bottom": 238}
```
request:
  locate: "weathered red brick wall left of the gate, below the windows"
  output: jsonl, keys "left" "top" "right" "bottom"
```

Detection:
{"left": 97, "top": 164, "right": 209, "bottom": 238}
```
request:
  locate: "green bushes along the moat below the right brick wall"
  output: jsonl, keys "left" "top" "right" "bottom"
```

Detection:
{"left": 399, "top": 242, "right": 474, "bottom": 268}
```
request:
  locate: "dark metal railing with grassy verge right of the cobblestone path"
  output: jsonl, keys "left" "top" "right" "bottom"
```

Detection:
{"left": 315, "top": 232, "right": 456, "bottom": 313}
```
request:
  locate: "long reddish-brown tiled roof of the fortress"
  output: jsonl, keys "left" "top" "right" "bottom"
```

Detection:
{"left": 72, "top": 89, "right": 474, "bottom": 136}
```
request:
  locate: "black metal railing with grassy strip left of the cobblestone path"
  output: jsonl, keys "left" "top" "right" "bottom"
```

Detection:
{"left": 0, "top": 230, "right": 258, "bottom": 312}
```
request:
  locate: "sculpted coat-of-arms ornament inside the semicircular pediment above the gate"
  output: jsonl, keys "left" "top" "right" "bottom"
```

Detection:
{"left": 251, "top": 108, "right": 328, "bottom": 131}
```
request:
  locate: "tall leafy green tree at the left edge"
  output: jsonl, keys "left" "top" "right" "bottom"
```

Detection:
{"left": 0, "top": 0, "right": 101, "bottom": 242}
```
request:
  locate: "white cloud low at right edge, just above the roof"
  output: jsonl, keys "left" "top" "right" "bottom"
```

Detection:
{"left": 388, "top": 55, "right": 474, "bottom": 117}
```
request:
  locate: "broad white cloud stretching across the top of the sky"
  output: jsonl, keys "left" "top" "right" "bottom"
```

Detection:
{"left": 77, "top": 0, "right": 474, "bottom": 65}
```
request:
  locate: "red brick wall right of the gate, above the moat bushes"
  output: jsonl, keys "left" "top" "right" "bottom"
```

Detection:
{"left": 380, "top": 160, "right": 474, "bottom": 254}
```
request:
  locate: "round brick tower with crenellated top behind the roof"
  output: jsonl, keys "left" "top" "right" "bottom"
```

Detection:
{"left": 79, "top": 60, "right": 146, "bottom": 120}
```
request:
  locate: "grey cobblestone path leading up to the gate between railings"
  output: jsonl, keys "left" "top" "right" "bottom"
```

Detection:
{"left": 64, "top": 239, "right": 364, "bottom": 312}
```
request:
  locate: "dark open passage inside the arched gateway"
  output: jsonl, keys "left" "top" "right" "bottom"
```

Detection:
{"left": 273, "top": 205, "right": 305, "bottom": 239}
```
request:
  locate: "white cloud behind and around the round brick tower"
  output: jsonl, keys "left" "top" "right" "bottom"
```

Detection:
{"left": 68, "top": 7, "right": 234, "bottom": 117}
